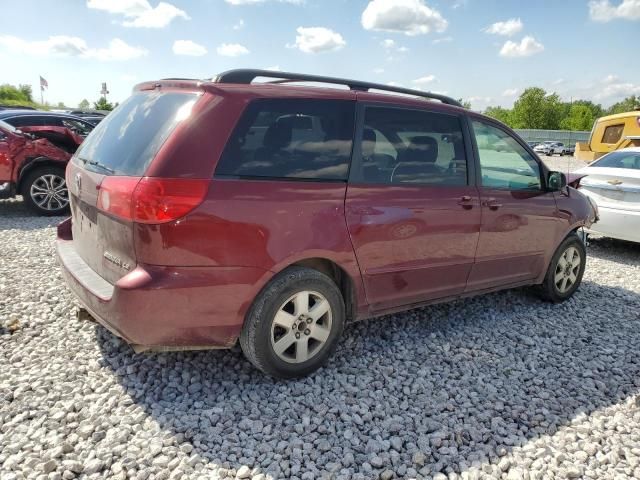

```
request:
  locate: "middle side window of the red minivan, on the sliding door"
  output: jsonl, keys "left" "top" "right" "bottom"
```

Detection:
{"left": 352, "top": 107, "right": 467, "bottom": 186}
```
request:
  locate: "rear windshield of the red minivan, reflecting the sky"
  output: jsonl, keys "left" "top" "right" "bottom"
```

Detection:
{"left": 76, "top": 91, "right": 198, "bottom": 176}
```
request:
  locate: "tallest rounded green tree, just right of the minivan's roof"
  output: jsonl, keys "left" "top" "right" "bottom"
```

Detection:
{"left": 511, "top": 87, "right": 562, "bottom": 130}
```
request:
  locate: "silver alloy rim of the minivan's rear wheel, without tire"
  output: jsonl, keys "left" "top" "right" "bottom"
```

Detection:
{"left": 271, "top": 290, "right": 332, "bottom": 363}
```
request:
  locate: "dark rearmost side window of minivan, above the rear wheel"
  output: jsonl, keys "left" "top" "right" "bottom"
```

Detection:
{"left": 215, "top": 99, "right": 355, "bottom": 181}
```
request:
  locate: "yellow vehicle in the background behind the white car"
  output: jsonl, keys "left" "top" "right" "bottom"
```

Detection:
{"left": 575, "top": 110, "right": 640, "bottom": 162}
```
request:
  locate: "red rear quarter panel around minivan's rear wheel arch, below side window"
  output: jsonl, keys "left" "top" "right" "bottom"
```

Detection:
{"left": 135, "top": 179, "right": 365, "bottom": 315}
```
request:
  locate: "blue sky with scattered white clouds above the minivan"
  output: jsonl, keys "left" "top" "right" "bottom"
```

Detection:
{"left": 0, "top": 0, "right": 640, "bottom": 110}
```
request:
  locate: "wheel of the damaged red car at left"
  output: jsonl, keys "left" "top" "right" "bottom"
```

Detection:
{"left": 21, "top": 167, "right": 69, "bottom": 216}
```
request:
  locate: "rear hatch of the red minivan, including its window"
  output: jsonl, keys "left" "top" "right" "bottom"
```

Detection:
{"left": 67, "top": 90, "right": 198, "bottom": 283}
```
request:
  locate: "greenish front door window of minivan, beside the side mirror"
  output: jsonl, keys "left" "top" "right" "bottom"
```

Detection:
{"left": 471, "top": 120, "right": 542, "bottom": 190}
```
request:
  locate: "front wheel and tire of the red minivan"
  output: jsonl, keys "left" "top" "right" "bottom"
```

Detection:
{"left": 540, "top": 232, "right": 587, "bottom": 303}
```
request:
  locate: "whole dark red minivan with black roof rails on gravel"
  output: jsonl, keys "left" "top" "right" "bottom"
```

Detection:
{"left": 57, "top": 70, "right": 596, "bottom": 377}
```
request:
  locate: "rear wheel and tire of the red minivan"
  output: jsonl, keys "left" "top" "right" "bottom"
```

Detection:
{"left": 240, "top": 267, "right": 345, "bottom": 378}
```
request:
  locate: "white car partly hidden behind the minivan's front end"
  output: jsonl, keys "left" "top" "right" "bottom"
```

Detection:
{"left": 572, "top": 147, "right": 640, "bottom": 242}
